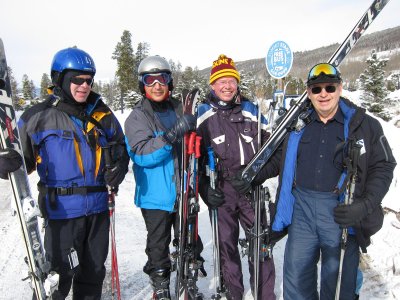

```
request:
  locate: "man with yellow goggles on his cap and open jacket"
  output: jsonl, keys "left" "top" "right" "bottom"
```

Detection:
{"left": 233, "top": 63, "right": 396, "bottom": 300}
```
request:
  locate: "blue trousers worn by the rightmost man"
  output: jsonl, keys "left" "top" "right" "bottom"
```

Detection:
{"left": 283, "top": 187, "right": 359, "bottom": 300}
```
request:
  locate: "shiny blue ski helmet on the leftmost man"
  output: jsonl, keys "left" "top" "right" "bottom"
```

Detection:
{"left": 50, "top": 48, "right": 96, "bottom": 86}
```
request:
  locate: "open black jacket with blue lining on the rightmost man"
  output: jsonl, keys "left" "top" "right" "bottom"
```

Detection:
{"left": 254, "top": 98, "right": 396, "bottom": 251}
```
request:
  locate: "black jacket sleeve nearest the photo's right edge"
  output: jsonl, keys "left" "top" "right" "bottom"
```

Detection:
{"left": 362, "top": 118, "right": 396, "bottom": 213}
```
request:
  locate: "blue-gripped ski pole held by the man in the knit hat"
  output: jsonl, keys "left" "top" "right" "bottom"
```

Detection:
{"left": 207, "top": 147, "right": 222, "bottom": 299}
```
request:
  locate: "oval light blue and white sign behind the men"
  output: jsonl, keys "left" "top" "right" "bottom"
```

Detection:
{"left": 265, "top": 41, "right": 293, "bottom": 79}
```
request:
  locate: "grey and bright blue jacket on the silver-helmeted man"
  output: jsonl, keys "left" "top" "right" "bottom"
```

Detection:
{"left": 124, "top": 98, "right": 182, "bottom": 212}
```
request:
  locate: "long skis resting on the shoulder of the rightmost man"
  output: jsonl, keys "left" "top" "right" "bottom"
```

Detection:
{"left": 242, "top": 0, "right": 389, "bottom": 182}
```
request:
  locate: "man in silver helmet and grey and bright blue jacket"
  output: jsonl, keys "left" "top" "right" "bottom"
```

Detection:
{"left": 125, "top": 56, "right": 202, "bottom": 300}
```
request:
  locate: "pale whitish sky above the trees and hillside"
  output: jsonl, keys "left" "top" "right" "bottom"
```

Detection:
{"left": 0, "top": 0, "right": 400, "bottom": 84}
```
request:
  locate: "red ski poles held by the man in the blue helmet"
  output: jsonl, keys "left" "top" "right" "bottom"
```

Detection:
{"left": 103, "top": 143, "right": 121, "bottom": 300}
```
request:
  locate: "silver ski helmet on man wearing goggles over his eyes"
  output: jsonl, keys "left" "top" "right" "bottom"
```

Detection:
{"left": 138, "top": 55, "right": 174, "bottom": 94}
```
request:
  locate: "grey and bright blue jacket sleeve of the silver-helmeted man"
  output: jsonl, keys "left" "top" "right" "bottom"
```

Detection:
{"left": 125, "top": 109, "right": 172, "bottom": 167}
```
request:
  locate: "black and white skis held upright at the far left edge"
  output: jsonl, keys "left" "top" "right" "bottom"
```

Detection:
{"left": 0, "top": 39, "right": 58, "bottom": 300}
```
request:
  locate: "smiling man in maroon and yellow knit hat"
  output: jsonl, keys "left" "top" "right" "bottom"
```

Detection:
{"left": 197, "top": 55, "right": 275, "bottom": 300}
